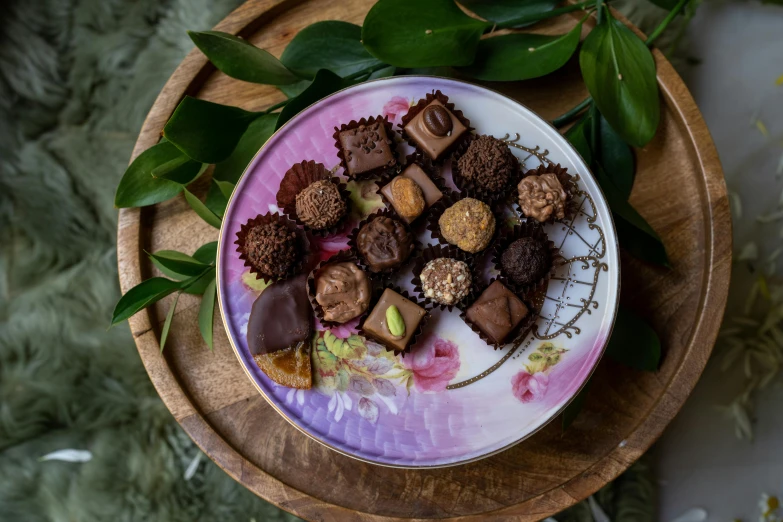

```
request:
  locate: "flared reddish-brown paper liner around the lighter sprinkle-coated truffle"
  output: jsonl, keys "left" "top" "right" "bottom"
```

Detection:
{"left": 277, "top": 160, "right": 351, "bottom": 237}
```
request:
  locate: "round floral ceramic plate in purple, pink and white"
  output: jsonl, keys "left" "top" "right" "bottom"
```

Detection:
{"left": 217, "top": 77, "right": 620, "bottom": 468}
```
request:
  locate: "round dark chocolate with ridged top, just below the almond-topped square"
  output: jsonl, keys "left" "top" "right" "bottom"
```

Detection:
{"left": 356, "top": 216, "right": 413, "bottom": 272}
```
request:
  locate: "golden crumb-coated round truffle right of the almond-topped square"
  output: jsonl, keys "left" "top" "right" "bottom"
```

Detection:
{"left": 438, "top": 198, "right": 495, "bottom": 254}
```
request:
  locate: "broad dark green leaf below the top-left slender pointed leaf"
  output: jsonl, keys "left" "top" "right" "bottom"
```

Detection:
{"left": 163, "top": 96, "right": 259, "bottom": 163}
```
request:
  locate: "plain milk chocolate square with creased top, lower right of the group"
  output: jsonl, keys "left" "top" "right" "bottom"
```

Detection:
{"left": 465, "top": 281, "right": 529, "bottom": 344}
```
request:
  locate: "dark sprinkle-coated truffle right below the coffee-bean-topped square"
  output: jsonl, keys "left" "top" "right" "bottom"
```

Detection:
{"left": 458, "top": 136, "right": 519, "bottom": 192}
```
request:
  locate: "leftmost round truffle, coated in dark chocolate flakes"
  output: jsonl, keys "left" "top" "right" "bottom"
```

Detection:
{"left": 242, "top": 221, "right": 301, "bottom": 277}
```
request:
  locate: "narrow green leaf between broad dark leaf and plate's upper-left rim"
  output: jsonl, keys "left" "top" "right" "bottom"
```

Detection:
{"left": 204, "top": 114, "right": 278, "bottom": 216}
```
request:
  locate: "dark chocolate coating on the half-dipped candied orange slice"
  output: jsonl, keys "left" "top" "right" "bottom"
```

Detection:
{"left": 247, "top": 275, "right": 313, "bottom": 355}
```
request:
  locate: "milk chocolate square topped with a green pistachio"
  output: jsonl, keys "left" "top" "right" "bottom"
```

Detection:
{"left": 362, "top": 288, "right": 427, "bottom": 352}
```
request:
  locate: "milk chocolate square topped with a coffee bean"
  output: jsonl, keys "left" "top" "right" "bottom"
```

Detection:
{"left": 405, "top": 100, "right": 468, "bottom": 160}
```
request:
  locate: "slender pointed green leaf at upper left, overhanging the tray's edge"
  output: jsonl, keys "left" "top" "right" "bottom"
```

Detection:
{"left": 188, "top": 31, "right": 299, "bottom": 85}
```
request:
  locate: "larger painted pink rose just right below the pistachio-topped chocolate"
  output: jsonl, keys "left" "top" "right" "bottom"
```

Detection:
{"left": 404, "top": 337, "right": 460, "bottom": 391}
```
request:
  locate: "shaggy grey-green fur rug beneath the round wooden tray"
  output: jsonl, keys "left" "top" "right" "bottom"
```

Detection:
{"left": 0, "top": 0, "right": 668, "bottom": 522}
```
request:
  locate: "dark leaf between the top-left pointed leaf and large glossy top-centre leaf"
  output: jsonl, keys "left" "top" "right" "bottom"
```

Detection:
{"left": 280, "top": 20, "right": 381, "bottom": 78}
